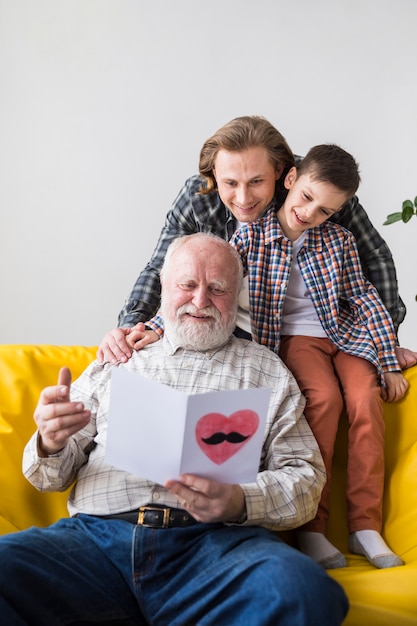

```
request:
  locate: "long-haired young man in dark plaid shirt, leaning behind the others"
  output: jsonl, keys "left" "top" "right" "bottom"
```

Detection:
{"left": 97, "top": 116, "right": 417, "bottom": 367}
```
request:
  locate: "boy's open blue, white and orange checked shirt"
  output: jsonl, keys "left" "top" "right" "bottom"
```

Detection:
{"left": 230, "top": 211, "right": 400, "bottom": 382}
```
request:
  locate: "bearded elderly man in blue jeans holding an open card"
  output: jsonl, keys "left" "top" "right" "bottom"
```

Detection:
{"left": 0, "top": 233, "right": 348, "bottom": 626}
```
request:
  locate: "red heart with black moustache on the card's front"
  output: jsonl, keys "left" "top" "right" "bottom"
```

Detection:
{"left": 195, "top": 409, "right": 259, "bottom": 465}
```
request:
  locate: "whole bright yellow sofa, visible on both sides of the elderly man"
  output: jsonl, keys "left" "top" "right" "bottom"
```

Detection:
{"left": 0, "top": 345, "right": 417, "bottom": 626}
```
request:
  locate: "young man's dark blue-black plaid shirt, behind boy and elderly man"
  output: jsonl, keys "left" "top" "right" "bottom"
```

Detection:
{"left": 118, "top": 175, "right": 406, "bottom": 329}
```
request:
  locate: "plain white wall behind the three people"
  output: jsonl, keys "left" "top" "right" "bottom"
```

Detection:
{"left": 0, "top": 0, "right": 417, "bottom": 348}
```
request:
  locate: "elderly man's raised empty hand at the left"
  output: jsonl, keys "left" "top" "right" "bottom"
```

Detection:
{"left": 34, "top": 367, "right": 91, "bottom": 457}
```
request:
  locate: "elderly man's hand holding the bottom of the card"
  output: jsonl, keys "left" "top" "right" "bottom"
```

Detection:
{"left": 165, "top": 474, "right": 246, "bottom": 523}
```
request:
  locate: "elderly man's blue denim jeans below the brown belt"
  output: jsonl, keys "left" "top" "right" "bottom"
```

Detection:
{"left": 0, "top": 515, "right": 348, "bottom": 626}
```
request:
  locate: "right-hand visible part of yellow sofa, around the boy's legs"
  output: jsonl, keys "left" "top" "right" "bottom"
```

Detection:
{"left": 328, "top": 366, "right": 417, "bottom": 626}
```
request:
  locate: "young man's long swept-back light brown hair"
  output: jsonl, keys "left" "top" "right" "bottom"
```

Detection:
{"left": 199, "top": 115, "right": 295, "bottom": 193}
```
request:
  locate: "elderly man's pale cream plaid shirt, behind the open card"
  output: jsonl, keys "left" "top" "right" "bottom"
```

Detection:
{"left": 23, "top": 337, "right": 325, "bottom": 529}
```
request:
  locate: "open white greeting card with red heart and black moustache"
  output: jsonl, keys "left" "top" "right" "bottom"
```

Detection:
{"left": 105, "top": 368, "right": 270, "bottom": 484}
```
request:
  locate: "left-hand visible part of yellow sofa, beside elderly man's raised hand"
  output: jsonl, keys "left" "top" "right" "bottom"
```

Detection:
{"left": 0, "top": 345, "right": 97, "bottom": 534}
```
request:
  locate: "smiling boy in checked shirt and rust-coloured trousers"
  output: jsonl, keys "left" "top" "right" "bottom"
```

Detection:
{"left": 231, "top": 145, "right": 407, "bottom": 568}
